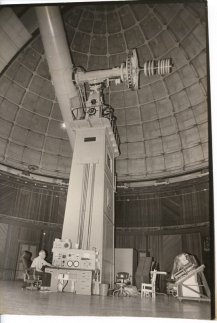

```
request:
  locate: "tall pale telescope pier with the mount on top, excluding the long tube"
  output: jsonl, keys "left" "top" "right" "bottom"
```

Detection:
{"left": 62, "top": 49, "right": 172, "bottom": 284}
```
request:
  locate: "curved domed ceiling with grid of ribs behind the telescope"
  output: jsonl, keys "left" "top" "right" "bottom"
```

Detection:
{"left": 0, "top": 3, "right": 208, "bottom": 181}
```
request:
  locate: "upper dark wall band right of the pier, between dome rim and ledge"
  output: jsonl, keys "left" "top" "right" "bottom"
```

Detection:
{"left": 116, "top": 176, "right": 210, "bottom": 228}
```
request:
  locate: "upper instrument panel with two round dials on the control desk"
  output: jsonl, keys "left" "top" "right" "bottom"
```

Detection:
{"left": 52, "top": 239, "right": 96, "bottom": 270}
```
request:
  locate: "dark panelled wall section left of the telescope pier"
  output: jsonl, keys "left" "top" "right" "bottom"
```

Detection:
{"left": 0, "top": 172, "right": 67, "bottom": 280}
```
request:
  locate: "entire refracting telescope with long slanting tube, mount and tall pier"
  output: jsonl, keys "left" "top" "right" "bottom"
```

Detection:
{"left": 36, "top": 6, "right": 172, "bottom": 285}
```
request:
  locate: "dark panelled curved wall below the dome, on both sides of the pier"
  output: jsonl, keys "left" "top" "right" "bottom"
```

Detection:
{"left": 0, "top": 172, "right": 211, "bottom": 279}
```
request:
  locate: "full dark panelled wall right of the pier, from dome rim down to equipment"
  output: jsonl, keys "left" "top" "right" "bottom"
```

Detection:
{"left": 115, "top": 176, "right": 213, "bottom": 286}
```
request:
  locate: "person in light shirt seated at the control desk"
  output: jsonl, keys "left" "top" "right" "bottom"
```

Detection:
{"left": 31, "top": 250, "right": 53, "bottom": 287}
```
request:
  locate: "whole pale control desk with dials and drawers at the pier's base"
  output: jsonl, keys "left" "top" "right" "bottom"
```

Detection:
{"left": 49, "top": 239, "right": 99, "bottom": 295}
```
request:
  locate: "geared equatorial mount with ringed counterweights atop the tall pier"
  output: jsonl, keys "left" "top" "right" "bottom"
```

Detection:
{"left": 72, "top": 49, "right": 173, "bottom": 142}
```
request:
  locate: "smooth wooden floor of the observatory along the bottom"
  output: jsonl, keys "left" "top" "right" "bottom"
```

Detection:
{"left": 0, "top": 281, "right": 211, "bottom": 319}
